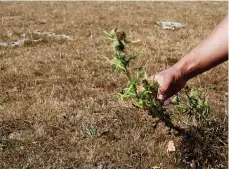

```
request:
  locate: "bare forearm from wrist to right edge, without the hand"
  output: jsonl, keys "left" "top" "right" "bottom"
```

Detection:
{"left": 174, "top": 17, "right": 228, "bottom": 80}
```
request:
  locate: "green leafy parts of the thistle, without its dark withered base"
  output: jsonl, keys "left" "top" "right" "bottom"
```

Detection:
{"left": 105, "top": 29, "right": 216, "bottom": 133}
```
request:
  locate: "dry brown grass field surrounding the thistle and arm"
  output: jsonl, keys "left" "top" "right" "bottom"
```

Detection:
{"left": 0, "top": 2, "right": 228, "bottom": 169}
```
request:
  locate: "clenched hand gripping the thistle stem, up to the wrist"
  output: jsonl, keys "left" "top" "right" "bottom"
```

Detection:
{"left": 150, "top": 66, "right": 187, "bottom": 100}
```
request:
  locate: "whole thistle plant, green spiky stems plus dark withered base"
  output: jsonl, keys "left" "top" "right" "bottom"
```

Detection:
{"left": 105, "top": 29, "right": 227, "bottom": 167}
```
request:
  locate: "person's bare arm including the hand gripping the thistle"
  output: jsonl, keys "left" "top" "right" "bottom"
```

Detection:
{"left": 155, "top": 16, "right": 228, "bottom": 100}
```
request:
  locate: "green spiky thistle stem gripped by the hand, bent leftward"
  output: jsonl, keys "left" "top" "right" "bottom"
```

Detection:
{"left": 105, "top": 29, "right": 183, "bottom": 132}
